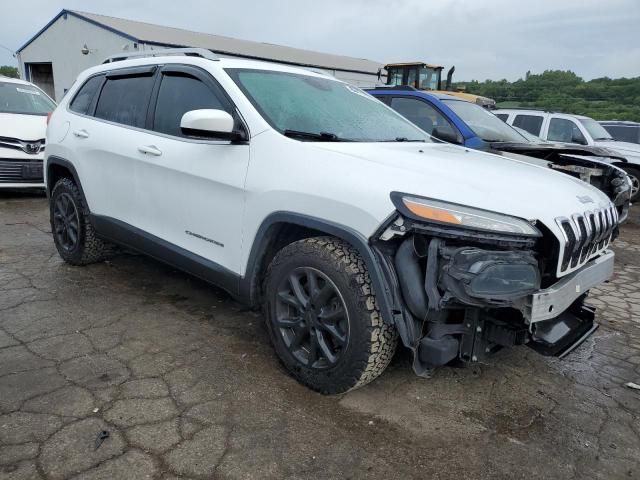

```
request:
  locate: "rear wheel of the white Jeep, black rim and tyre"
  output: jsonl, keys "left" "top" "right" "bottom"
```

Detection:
{"left": 49, "top": 178, "right": 113, "bottom": 265}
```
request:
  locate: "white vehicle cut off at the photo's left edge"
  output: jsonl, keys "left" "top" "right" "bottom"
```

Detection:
{"left": 0, "top": 75, "right": 56, "bottom": 189}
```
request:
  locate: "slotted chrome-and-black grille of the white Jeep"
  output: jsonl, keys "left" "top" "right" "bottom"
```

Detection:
{"left": 556, "top": 205, "right": 619, "bottom": 273}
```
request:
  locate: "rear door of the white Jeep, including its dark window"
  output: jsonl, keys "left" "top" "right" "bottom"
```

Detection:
{"left": 67, "top": 66, "right": 157, "bottom": 225}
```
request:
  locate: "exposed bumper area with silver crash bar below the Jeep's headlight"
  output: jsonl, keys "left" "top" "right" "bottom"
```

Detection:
{"left": 388, "top": 237, "right": 614, "bottom": 375}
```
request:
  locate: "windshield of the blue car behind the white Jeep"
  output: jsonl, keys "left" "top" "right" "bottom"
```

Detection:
{"left": 443, "top": 100, "right": 529, "bottom": 143}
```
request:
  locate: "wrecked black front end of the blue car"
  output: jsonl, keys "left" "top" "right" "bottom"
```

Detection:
{"left": 491, "top": 143, "right": 631, "bottom": 222}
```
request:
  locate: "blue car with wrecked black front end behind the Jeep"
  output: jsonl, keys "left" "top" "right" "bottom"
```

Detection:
{"left": 367, "top": 86, "right": 631, "bottom": 214}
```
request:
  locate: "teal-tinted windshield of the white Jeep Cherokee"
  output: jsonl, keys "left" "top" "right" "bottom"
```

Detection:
{"left": 226, "top": 69, "right": 431, "bottom": 142}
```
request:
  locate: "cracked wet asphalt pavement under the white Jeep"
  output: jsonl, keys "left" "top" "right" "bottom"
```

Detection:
{"left": 0, "top": 193, "right": 640, "bottom": 480}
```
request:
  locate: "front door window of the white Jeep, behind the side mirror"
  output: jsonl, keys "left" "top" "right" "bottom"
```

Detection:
{"left": 153, "top": 74, "right": 228, "bottom": 136}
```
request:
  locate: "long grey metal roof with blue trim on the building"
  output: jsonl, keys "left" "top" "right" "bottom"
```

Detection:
{"left": 18, "top": 10, "right": 383, "bottom": 75}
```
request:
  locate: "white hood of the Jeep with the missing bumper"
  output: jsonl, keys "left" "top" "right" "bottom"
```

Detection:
{"left": 313, "top": 143, "right": 611, "bottom": 229}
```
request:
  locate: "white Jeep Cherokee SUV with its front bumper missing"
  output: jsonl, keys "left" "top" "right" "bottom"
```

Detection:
{"left": 46, "top": 50, "right": 619, "bottom": 393}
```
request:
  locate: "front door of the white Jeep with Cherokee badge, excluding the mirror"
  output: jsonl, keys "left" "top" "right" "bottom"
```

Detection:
{"left": 135, "top": 65, "right": 249, "bottom": 272}
